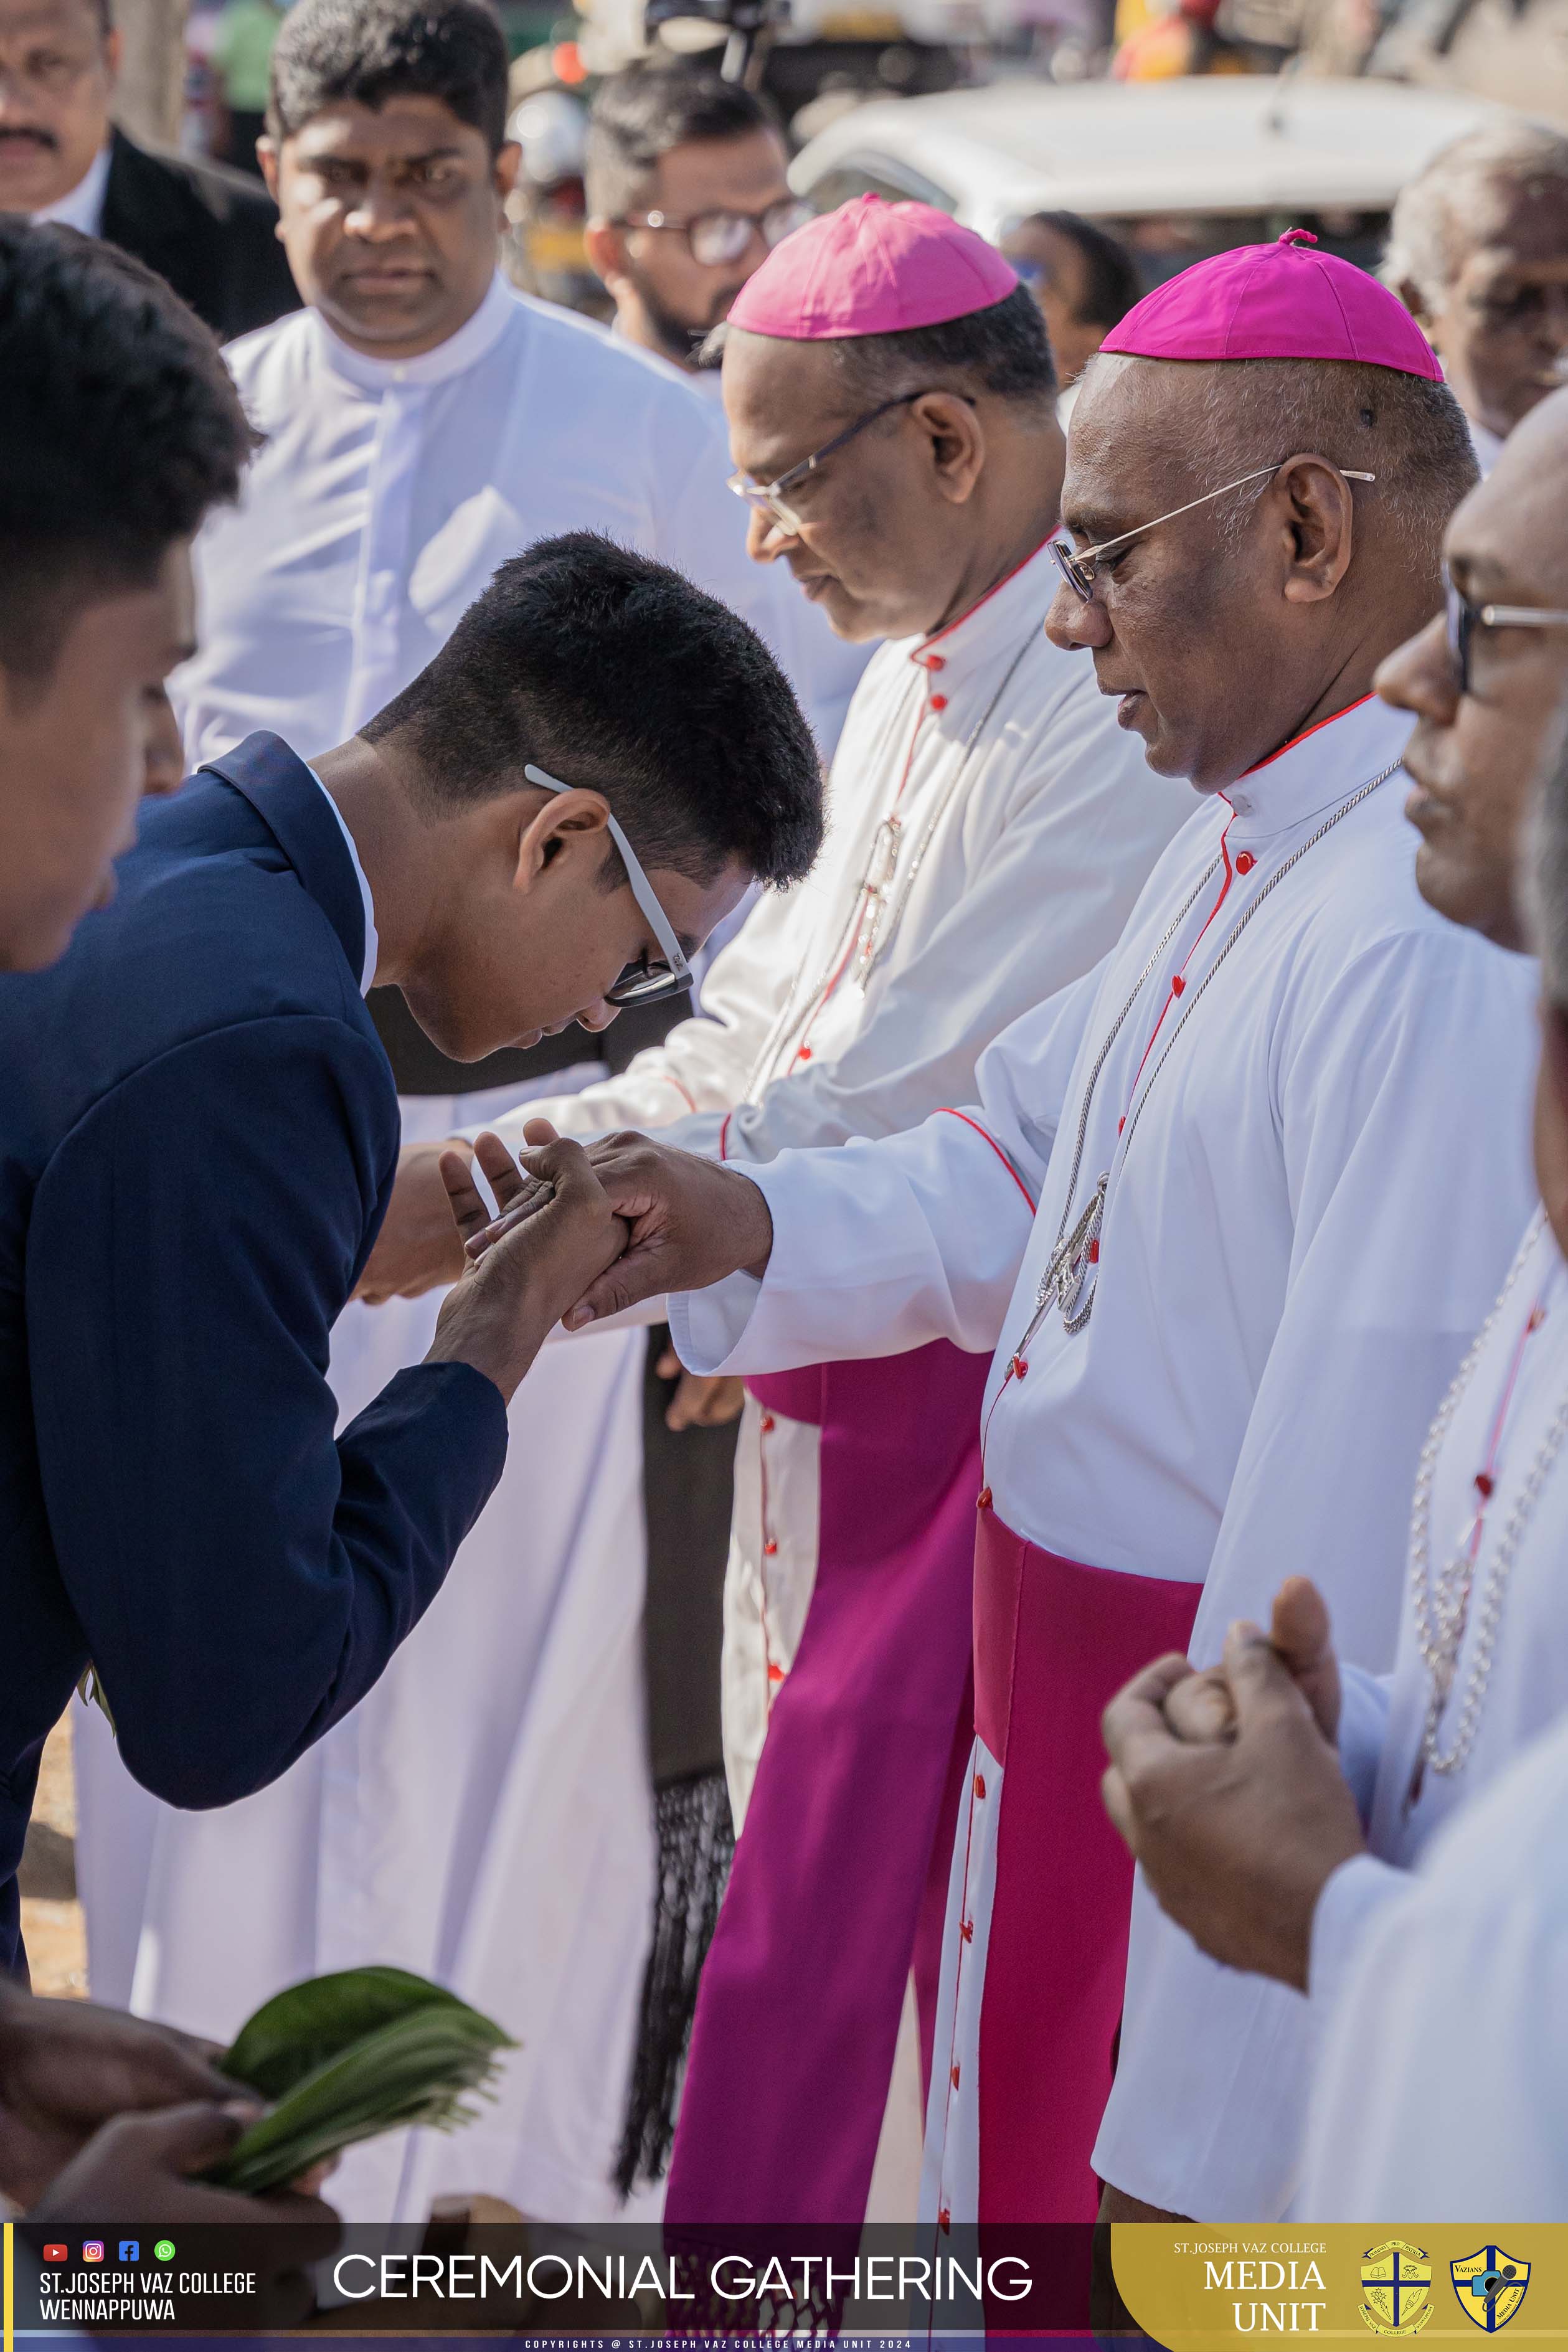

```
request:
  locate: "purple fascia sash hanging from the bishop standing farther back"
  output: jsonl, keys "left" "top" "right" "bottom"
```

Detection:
{"left": 665, "top": 1341, "right": 989, "bottom": 2234}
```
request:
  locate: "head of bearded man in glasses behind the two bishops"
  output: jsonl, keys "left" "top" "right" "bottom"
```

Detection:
{"left": 583, "top": 61, "right": 811, "bottom": 383}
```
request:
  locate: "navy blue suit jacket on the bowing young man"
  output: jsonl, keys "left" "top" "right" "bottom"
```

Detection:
{"left": 0, "top": 736, "right": 506, "bottom": 1967}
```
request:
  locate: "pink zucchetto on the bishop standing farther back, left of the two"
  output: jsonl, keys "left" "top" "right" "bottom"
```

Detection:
{"left": 729, "top": 195, "right": 1018, "bottom": 343}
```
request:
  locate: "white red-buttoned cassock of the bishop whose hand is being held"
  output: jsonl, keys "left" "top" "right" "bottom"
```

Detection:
{"left": 673, "top": 701, "right": 1533, "bottom": 2220}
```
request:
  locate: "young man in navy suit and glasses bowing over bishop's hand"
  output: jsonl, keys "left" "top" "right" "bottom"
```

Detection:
{"left": 0, "top": 519, "right": 823, "bottom": 1967}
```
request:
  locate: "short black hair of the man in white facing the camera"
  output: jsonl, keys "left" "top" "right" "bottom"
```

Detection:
{"left": 266, "top": 0, "right": 508, "bottom": 155}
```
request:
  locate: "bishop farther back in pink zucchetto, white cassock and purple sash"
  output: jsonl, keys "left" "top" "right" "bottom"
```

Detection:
{"left": 362, "top": 197, "right": 1189, "bottom": 2222}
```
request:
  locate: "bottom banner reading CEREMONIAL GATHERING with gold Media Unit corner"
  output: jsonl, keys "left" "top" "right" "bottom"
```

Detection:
{"left": 5, "top": 2209, "right": 1568, "bottom": 2352}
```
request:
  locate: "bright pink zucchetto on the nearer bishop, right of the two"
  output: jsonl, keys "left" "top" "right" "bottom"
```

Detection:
{"left": 1100, "top": 228, "right": 1443, "bottom": 384}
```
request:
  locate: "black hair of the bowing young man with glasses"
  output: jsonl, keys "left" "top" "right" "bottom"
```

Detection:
{"left": 362, "top": 532, "right": 823, "bottom": 887}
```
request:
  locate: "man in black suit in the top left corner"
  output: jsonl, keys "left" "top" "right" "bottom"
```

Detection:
{"left": 0, "top": 0, "right": 298, "bottom": 341}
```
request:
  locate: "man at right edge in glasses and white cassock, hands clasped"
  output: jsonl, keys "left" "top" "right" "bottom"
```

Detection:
{"left": 1107, "top": 362, "right": 1568, "bottom": 2220}
